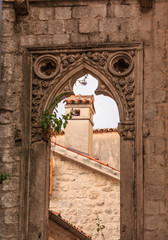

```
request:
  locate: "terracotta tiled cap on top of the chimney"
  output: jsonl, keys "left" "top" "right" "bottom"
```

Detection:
{"left": 64, "top": 95, "right": 94, "bottom": 104}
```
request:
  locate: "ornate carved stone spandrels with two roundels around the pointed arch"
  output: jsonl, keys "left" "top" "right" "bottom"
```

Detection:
{"left": 32, "top": 50, "right": 136, "bottom": 141}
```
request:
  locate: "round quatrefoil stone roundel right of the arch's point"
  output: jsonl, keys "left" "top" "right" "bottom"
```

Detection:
{"left": 108, "top": 52, "right": 134, "bottom": 77}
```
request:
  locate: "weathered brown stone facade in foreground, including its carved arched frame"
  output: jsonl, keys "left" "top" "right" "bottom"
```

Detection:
{"left": 0, "top": 0, "right": 168, "bottom": 240}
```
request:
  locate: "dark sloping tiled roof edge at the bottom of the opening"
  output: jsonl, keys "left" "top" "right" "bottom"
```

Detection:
{"left": 49, "top": 210, "right": 92, "bottom": 240}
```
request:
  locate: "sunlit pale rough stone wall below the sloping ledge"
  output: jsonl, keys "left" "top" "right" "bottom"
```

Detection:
{"left": 49, "top": 152, "right": 120, "bottom": 240}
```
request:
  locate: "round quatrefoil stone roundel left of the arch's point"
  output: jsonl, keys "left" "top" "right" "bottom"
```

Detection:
{"left": 34, "top": 55, "right": 59, "bottom": 80}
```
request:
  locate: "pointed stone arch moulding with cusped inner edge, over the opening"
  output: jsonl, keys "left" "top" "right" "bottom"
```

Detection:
{"left": 43, "top": 61, "right": 125, "bottom": 121}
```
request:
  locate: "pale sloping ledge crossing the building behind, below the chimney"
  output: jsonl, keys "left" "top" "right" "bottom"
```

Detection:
{"left": 51, "top": 143, "right": 120, "bottom": 181}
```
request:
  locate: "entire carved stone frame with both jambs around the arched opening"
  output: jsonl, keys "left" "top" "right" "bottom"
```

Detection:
{"left": 20, "top": 43, "right": 143, "bottom": 240}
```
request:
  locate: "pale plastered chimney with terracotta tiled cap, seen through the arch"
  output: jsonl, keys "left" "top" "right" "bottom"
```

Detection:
{"left": 64, "top": 95, "right": 95, "bottom": 155}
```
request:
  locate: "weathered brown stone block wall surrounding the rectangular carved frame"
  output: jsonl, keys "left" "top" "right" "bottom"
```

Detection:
{"left": 0, "top": 0, "right": 168, "bottom": 240}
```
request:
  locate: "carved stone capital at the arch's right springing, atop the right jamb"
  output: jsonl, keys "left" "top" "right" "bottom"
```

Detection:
{"left": 118, "top": 121, "right": 135, "bottom": 140}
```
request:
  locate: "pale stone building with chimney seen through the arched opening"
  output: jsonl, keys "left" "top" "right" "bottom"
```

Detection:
{"left": 49, "top": 95, "right": 120, "bottom": 240}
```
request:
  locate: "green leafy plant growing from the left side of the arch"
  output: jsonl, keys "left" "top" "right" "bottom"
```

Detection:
{"left": 41, "top": 92, "right": 73, "bottom": 137}
